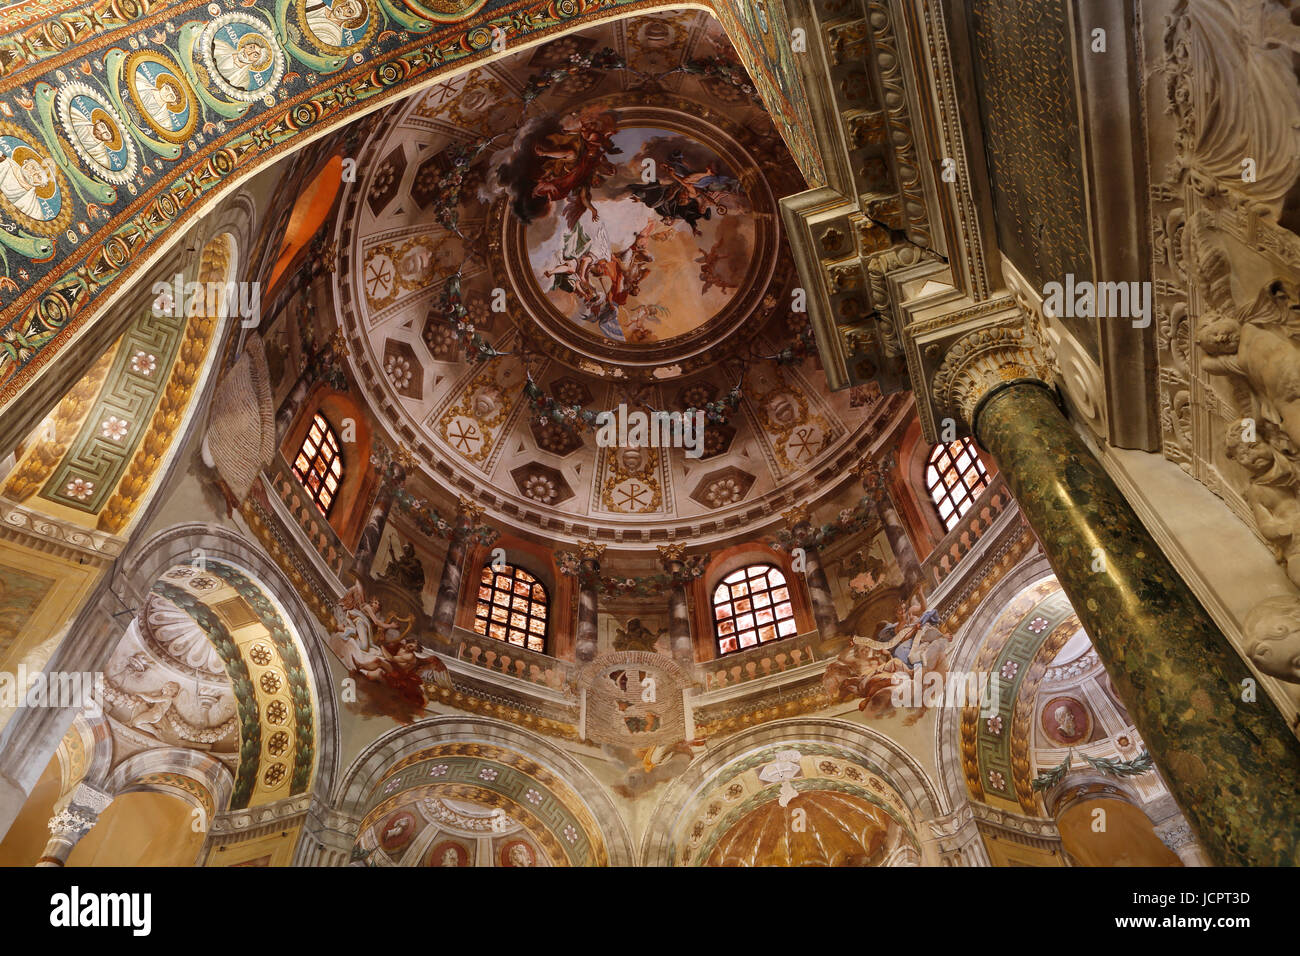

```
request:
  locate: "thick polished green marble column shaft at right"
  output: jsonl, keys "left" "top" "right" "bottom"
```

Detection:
{"left": 971, "top": 381, "right": 1300, "bottom": 865}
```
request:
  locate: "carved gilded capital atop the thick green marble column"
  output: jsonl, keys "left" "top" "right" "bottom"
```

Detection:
{"left": 931, "top": 325, "right": 1053, "bottom": 428}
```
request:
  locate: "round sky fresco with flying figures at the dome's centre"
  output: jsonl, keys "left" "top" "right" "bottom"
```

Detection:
{"left": 501, "top": 108, "right": 755, "bottom": 345}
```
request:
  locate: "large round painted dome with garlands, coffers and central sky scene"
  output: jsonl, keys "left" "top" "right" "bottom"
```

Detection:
{"left": 334, "top": 12, "right": 894, "bottom": 542}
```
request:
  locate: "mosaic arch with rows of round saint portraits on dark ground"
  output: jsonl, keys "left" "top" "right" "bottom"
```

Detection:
{"left": 0, "top": 0, "right": 820, "bottom": 416}
